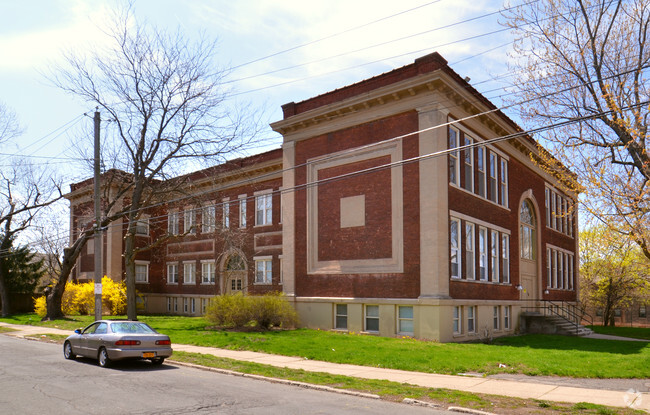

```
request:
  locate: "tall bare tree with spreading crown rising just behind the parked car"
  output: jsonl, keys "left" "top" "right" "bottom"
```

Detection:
{"left": 52, "top": 6, "right": 258, "bottom": 319}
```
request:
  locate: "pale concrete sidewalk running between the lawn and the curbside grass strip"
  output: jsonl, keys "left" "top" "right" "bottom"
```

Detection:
{"left": 0, "top": 322, "right": 650, "bottom": 412}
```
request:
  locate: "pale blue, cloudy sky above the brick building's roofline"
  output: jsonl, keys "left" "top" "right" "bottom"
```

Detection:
{"left": 0, "top": 0, "right": 511, "bottom": 183}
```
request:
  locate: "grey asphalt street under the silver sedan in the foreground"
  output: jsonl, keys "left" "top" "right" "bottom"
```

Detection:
{"left": 0, "top": 336, "right": 448, "bottom": 415}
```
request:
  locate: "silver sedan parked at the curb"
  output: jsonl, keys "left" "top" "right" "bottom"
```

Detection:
{"left": 63, "top": 320, "right": 172, "bottom": 367}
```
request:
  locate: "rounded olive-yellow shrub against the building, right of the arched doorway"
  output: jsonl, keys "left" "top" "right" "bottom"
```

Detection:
{"left": 205, "top": 293, "right": 298, "bottom": 330}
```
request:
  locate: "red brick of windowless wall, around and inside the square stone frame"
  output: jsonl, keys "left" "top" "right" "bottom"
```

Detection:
{"left": 295, "top": 111, "right": 420, "bottom": 298}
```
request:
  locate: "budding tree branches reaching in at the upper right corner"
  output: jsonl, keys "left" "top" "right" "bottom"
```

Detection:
{"left": 506, "top": 0, "right": 650, "bottom": 258}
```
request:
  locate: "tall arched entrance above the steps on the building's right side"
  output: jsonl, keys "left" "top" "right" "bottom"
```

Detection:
{"left": 519, "top": 199, "right": 539, "bottom": 307}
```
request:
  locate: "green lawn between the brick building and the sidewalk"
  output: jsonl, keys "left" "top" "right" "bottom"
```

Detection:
{"left": 5, "top": 315, "right": 650, "bottom": 378}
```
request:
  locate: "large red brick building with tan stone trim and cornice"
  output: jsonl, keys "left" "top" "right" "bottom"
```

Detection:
{"left": 68, "top": 53, "right": 579, "bottom": 341}
